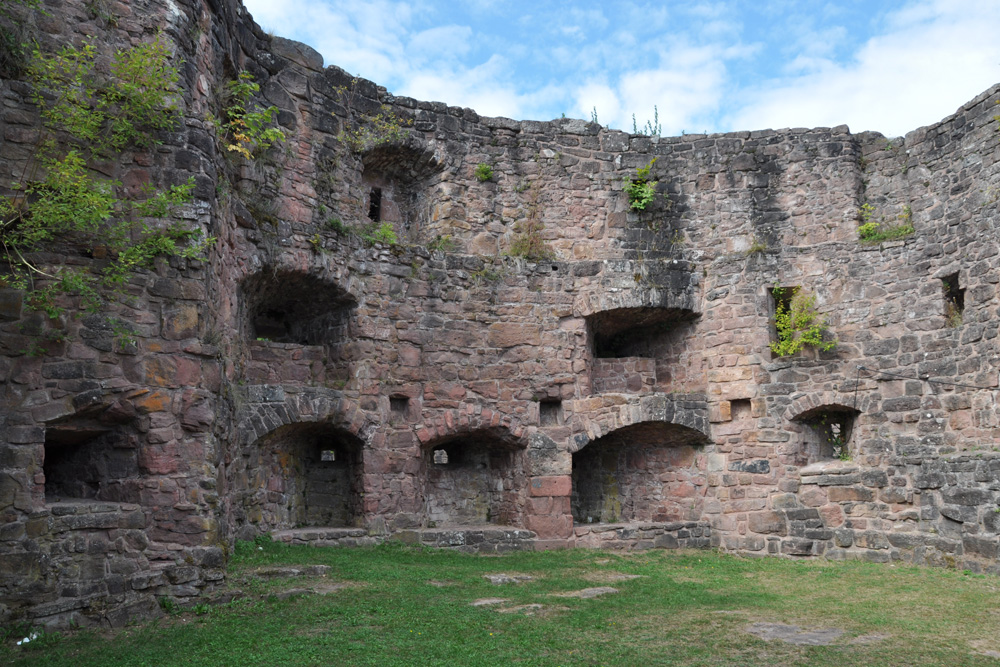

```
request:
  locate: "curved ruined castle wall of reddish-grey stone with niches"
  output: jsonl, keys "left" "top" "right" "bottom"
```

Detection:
{"left": 0, "top": 0, "right": 1000, "bottom": 624}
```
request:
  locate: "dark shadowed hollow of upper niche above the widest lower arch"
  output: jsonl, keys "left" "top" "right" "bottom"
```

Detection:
{"left": 587, "top": 308, "right": 698, "bottom": 359}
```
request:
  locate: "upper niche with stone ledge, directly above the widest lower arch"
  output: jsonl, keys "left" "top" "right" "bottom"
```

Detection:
{"left": 587, "top": 306, "right": 699, "bottom": 393}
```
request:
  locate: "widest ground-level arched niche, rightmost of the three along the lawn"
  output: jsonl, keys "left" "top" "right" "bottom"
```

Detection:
{"left": 570, "top": 421, "right": 708, "bottom": 524}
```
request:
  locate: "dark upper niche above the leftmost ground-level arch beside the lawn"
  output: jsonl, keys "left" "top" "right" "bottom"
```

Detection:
{"left": 240, "top": 267, "right": 357, "bottom": 345}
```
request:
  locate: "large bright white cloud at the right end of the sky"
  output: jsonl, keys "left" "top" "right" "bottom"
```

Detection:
{"left": 727, "top": 0, "right": 1000, "bottom": 136}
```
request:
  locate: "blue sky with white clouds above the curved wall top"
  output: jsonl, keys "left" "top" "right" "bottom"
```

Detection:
{"left": 245, "top": 0, "right": 1000, "bottom": 137}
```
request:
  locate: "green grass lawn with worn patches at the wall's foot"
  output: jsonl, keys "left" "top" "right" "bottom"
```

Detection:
{"left": 0, "top": 543, "right": 1000, "bottom": 667}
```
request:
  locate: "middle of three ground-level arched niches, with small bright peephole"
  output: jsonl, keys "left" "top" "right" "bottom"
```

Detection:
{"left": 422, "top": 428, "right": 527, "bottom": 527}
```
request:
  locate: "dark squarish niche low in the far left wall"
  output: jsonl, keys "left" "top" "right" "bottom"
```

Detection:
{"left": 42, "top": 421, "right": 140, "bottom": 503}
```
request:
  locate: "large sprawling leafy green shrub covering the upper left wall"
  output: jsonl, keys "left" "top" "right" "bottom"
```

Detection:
{"left": 0, "top": 36, "right": 212, "bottom": 332}
